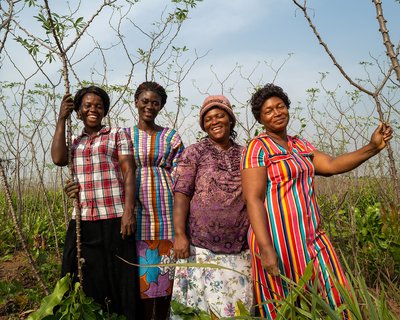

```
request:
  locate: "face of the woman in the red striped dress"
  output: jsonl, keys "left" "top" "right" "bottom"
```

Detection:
{"left": 260, "top": 97, "right": 289, "bottom": 133}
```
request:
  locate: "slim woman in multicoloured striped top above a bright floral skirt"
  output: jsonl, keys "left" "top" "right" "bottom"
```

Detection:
{"left": 130, "top": 82, "right": 183, "bottom": 320}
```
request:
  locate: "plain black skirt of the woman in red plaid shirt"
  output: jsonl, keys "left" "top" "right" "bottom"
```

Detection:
{"left": 61, "top": 218, "right": 139, "bottom": 320}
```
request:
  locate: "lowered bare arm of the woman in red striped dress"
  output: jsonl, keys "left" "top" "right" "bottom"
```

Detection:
{"left": 241, "top": 167, "right": 279, "bottom": 276}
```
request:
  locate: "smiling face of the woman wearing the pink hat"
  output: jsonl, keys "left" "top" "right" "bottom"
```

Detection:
{"left": 203, "top": 107, "right": 231, "bottom": 143}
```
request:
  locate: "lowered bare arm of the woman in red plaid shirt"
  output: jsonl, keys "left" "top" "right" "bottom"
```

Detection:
{"left": 118, "top": 155, "right": 136, "bottom": 239}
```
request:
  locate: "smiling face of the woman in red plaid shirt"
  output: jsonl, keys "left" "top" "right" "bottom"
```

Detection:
{"left": 78, "top": 93, "right": 105, "bottom": 134}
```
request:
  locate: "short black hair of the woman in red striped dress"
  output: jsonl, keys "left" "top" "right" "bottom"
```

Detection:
{"left": 250, "top": 83, "right": 290, "bottom": 122}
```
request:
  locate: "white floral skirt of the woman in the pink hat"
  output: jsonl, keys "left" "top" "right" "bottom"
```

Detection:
{"left": 172, "top": 246, "right": 253, "bottom": 319}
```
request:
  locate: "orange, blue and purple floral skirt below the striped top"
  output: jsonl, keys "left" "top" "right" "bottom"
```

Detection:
{"left": 136, "top": 240, "right": 174, "bottom": 299}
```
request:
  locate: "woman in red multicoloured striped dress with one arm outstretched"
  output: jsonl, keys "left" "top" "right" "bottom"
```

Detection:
{"left": 241, "top": 84, "right": 392, "bottom": 319}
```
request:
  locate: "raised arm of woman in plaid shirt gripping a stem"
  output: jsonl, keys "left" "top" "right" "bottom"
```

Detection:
{"left": 51, "top": 94, "right": 74, "bottom": 167}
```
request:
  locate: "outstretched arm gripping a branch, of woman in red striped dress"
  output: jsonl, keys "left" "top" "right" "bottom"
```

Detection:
{"left": 313, "top": 123, "right": 393, "bottom": 176}
